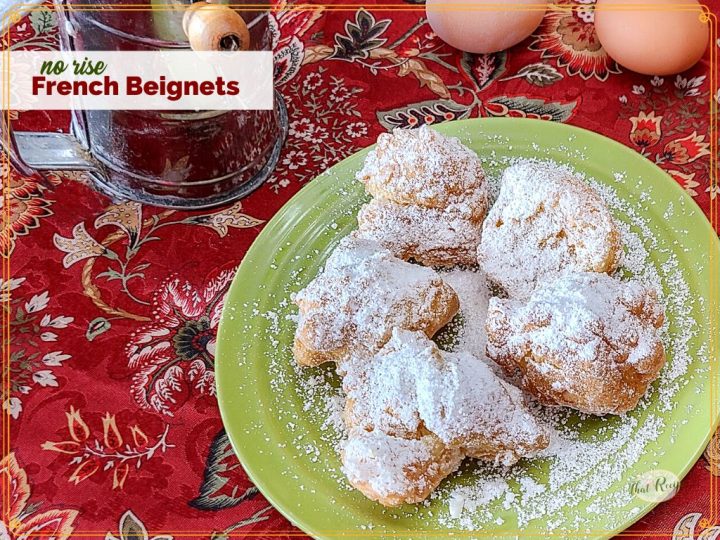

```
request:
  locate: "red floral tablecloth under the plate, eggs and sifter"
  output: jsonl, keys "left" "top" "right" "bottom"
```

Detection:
{"left": 5, "top": 0, "right": 720, "bottom": 540}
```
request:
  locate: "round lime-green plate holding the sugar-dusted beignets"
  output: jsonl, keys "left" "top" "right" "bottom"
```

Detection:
{"left": 216, "top": 118, "right": 720, "bottom": 538}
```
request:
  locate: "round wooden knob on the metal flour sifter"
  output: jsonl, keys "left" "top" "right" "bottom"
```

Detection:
{"left": 183, "top": 2, "right": 250, "bottom": 51}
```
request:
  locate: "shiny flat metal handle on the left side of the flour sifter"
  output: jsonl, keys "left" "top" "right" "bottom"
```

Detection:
{"left": 0, "top": 111, "right": 103, "bottom": 176}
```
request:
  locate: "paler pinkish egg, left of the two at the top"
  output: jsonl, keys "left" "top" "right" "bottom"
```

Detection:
{"left": 425, "top": 0, "right": 547, "bottom": 53}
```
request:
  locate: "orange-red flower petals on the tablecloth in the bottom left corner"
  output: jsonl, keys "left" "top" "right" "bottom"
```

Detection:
{"left": 0, "top": 452, "right": 78, "bottom": 540}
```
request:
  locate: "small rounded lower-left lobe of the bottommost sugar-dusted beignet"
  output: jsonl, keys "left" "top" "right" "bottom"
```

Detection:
{"left": 341, "top": 429, "right": 463, "bottom": 506}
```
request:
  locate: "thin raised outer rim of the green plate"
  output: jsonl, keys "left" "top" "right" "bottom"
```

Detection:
{"left": 215, "top": 117, "right": 720, "bottom": 540}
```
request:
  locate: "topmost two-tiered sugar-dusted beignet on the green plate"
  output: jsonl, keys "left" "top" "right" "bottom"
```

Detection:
{"left": 357, "top": 126, "right": 488, "bottom": 266}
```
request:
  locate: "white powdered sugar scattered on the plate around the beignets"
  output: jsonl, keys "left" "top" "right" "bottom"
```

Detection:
{"left": 242, "top": 141, "right": 707, "bottom": 530}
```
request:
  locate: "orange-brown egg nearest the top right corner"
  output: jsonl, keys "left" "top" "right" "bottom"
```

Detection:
{"left": 595, "top": 0, "right": 710, "bottom": 75}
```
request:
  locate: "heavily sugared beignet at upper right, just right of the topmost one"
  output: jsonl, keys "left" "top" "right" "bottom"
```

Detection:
{"left": 478, "top": 161, "right": 623, "bottom": 298}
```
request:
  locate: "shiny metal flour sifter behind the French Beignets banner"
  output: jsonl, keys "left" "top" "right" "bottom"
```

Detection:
{"left": 3, "top": 0, "right": 287, "bottom": 208}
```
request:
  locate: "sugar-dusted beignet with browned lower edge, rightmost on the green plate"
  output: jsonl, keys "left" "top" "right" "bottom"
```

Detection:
{"left": 486, "top": 272, "right": 665, "bottom": 415}
